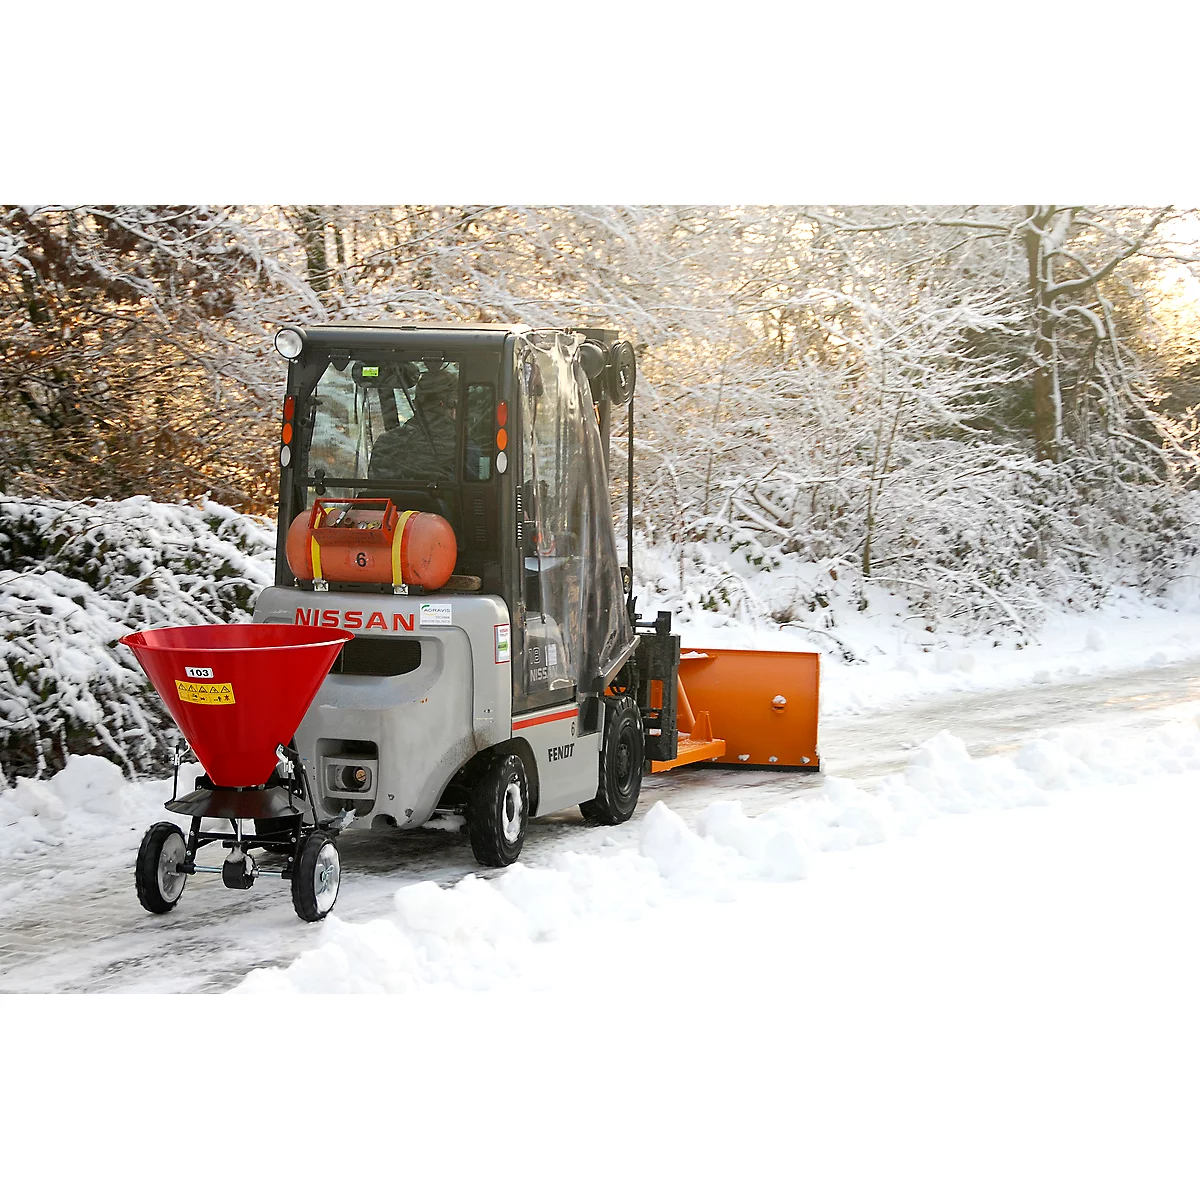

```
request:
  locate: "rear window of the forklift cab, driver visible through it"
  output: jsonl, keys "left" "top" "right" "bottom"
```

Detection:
{"left": 308, "top": 358, "right": 468, "bottom": 484}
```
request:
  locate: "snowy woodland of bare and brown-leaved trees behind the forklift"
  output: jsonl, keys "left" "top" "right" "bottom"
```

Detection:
{"left": 0, "top": 204, "right": 1200, "bottom": 635}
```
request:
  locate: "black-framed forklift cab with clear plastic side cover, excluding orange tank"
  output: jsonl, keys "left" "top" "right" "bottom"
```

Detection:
{"left": 276, "top": 324, "right": 635, "bottom": 724}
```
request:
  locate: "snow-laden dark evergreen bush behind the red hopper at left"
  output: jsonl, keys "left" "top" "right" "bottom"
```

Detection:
{"left": 0, "top": 496, "right": 275, "bottom": 786}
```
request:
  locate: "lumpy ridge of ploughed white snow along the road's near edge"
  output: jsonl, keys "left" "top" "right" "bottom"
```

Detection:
{"left": 236, "top": 720, "right": 1200, "bottom": 992}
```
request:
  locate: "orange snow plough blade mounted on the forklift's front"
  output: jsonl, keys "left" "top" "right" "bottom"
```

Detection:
{"left": 650, "top": 649, "right": 821, "bottom": 772}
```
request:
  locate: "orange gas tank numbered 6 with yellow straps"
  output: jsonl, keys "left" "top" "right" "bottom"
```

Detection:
{"left": 287, "top": 499, "right": 458, "bottom": 592}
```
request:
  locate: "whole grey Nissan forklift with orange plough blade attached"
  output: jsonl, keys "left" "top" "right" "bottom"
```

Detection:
{"left": 253, "top": 323, "right": 820, "bottom": 866}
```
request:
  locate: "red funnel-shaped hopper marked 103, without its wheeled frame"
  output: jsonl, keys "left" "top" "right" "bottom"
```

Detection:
{"left": 121, "top": 625, "right": 354, "bottom": 787}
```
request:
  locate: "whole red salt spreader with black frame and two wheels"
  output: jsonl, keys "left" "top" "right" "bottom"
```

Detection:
{"left": 121, "top": 625, "right": 353, "bottom": 920}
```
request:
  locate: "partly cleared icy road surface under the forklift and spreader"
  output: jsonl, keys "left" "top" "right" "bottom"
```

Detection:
{"left": 0, "top": 662, "right": 1200, "bottom": 991}
